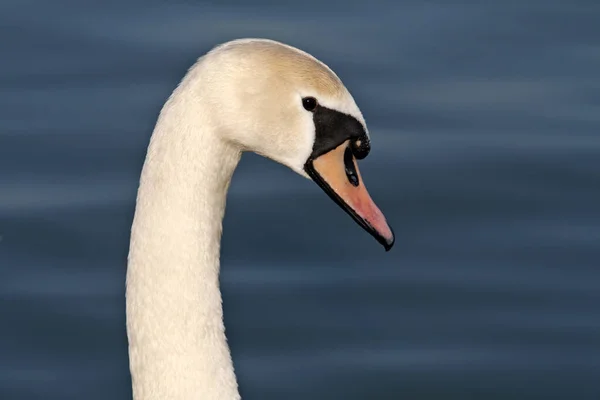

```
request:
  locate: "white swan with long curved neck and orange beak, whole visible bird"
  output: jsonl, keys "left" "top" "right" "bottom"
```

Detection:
{"left": 126, "top": 39, "right": 394, "bottom": 400}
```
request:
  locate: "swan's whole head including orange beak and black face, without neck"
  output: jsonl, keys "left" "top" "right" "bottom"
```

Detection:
{"left": 199, "top": 39, "right": 394, "bottom": 251}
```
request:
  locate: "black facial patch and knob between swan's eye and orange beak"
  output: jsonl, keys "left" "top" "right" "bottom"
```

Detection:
{"left": 309, "top": 104, "right": 371, "bottom": 161}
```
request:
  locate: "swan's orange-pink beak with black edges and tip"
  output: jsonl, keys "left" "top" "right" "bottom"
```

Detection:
{"left": 305, "top": 141, "right": 394, "bottom": 251}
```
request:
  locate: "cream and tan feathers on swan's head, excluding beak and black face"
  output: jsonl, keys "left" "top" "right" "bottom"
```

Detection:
{"left": 192, "top": 39, "right": 366, "bottom": 175}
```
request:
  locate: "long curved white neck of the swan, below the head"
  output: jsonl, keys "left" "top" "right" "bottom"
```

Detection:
{"left": 126, "top": 91, "right": 240, "bottom": 400}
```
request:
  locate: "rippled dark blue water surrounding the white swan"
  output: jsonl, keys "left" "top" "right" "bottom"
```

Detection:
{"left": 0, "top": 0, "right": 600, "bottom": 400}
